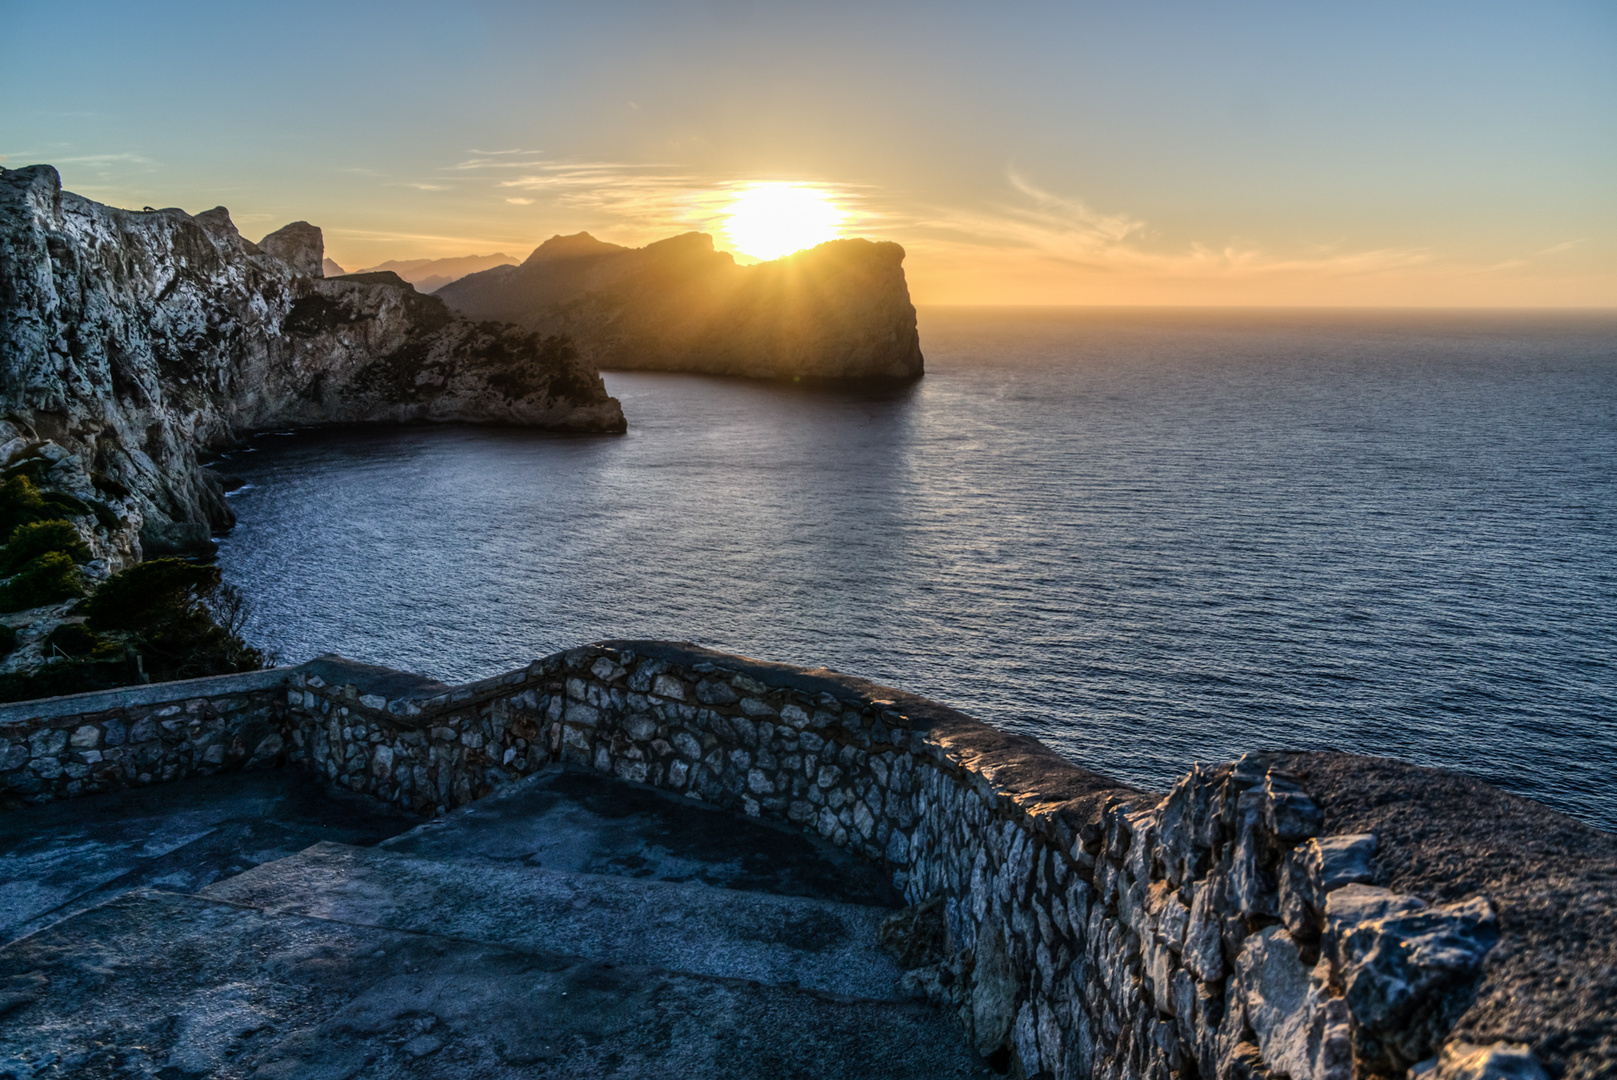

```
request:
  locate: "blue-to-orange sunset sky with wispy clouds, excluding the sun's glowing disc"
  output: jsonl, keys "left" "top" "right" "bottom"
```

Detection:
{"left": 0, "top": 0, "right": 1617, "bottom": 306}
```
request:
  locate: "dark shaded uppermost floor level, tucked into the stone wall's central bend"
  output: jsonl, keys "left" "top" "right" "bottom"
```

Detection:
{"left": 383, "top": 766, "right": 904, "bottom": 907}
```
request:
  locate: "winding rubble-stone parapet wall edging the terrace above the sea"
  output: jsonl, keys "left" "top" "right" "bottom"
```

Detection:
{"left": 0, "top": 642, "right": 1617, "bottom": 1080}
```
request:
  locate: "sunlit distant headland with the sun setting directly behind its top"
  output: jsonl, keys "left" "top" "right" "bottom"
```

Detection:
{"left": 435, "top": 233, "right": 923, "bottom": 380}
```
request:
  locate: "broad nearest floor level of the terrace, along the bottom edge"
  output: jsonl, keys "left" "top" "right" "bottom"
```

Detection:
{"left": 0, "top": 891, "right": 991, "bottom": 1080}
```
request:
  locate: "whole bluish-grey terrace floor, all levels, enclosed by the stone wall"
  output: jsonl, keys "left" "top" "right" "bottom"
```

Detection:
{"left": 0, "top": 768, "right": 991, "bottom": 1080}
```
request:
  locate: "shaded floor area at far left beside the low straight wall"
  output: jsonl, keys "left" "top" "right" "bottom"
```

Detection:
{"left": 0, "top": 770, "right": 417, "bottom": 941}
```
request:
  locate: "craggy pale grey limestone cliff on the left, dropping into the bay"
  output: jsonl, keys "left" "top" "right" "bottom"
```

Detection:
{"left": 0, "top": 165, "right": 624, "bottom": 564}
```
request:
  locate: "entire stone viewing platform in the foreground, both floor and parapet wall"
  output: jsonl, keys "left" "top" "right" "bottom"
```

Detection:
{"left": 0, "top": 642, "right": 1617, "bottom": 1080}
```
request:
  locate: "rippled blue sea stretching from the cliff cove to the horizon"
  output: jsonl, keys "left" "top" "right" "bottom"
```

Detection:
{"left": 220, "top": 309, "right": 1617, "bottom": 828}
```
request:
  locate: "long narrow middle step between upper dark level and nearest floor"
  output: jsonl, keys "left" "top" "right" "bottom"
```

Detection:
{"left": 202, "top": 844, "right": 904, "bottom": 999}
